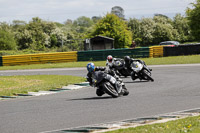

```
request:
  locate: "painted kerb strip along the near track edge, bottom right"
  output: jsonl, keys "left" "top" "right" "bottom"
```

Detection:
{"left": 41, "top": 108, "right": 200, "bottom": 133}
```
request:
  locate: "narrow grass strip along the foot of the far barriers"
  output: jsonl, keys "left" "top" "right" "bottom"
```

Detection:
{"left": 0, "top": 55, "right": 200, "bottom": 70}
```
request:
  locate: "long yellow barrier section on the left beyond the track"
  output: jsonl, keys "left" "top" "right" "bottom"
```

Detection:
{"left": 2, "top": 51, "right": 77, "bottom": 66}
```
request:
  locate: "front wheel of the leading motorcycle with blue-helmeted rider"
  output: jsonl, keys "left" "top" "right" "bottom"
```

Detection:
{"left": 103, "top": 82, "right": 119, "bottom": 98}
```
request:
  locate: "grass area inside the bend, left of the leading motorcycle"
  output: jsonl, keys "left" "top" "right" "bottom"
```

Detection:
{"left": 0, "top": 75, "right": 85, "bottom": 96}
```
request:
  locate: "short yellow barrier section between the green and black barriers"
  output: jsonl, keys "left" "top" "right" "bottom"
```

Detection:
{"left": 149, "top": 46, "right": 163, "bottom": 57}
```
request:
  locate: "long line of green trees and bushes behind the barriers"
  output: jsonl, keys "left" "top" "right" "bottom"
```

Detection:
{"left": 0, "top": 0, "right": 200, "bottom": 51}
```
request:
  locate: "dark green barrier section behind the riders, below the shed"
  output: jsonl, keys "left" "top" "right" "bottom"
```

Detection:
{"left": 77, "top": 47, "right": 149, "bottom": 61}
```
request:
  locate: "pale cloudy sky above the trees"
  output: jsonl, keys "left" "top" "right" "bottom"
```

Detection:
{"left": 0, "top": 0, "right": 196, "bottom": 23}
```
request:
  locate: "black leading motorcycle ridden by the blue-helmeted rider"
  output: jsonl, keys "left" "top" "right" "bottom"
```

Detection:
{"left": 89, "top": 72, "right": 129, "bottom": 98}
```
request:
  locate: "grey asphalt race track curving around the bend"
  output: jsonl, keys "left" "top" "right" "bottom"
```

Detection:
{"left": 0, "top": 64, "right": 200, "bottom": 133}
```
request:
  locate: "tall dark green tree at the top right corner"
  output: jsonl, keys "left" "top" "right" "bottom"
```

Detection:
{"left": 186, "top": 0, "right": 200, "bottom": 41}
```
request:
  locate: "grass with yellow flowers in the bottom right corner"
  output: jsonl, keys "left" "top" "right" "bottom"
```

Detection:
{"left": 106, "top": 116, "right": 200, "bottom": 133}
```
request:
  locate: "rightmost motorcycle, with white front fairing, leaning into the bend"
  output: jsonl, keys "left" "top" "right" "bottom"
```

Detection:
{"left": 131, "top": 61, "right": 154, "bottom": 82}
